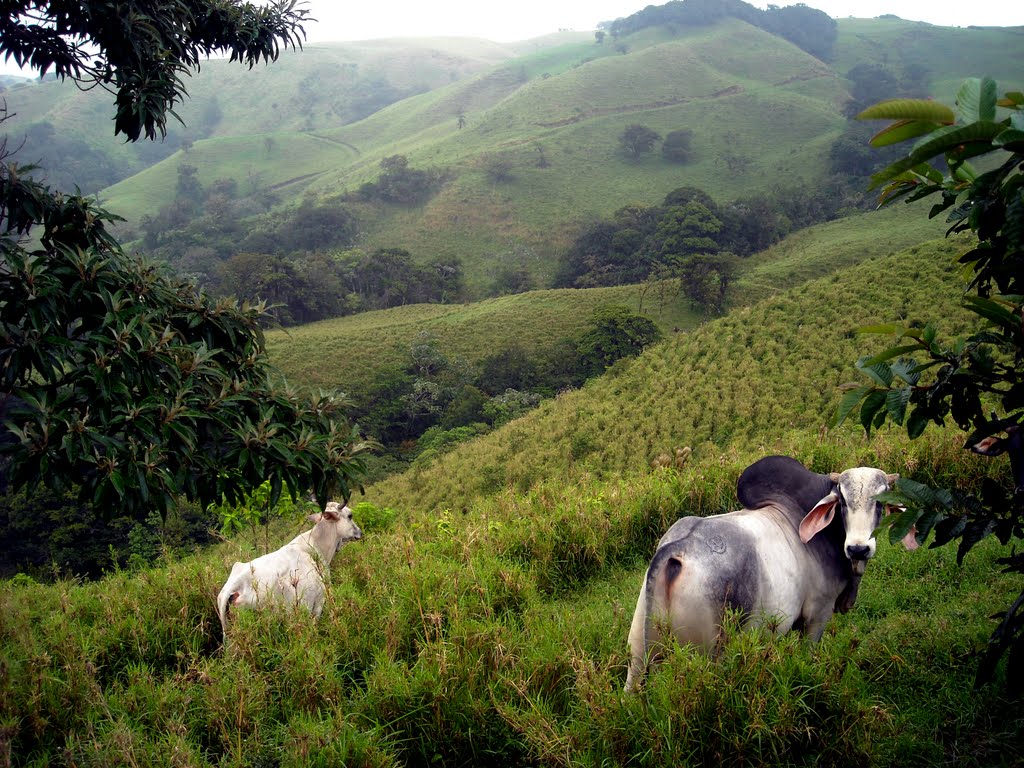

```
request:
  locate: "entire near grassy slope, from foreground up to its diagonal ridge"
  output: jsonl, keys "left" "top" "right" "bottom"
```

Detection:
{"left": 0, "top": 225, "right": 1024, "bottom": 766}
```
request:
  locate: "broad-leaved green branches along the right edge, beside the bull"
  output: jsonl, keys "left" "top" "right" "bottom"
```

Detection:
{"left": 836, "top": 78, "right": 1024, "bottom": 687}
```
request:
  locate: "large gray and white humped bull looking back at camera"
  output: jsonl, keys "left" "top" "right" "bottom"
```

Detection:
{"left": 626, "top": 456, "right": 918, "bottom": 691}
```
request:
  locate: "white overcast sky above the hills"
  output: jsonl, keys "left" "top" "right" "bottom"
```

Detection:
{"left": 0, "top": 0, "right": 1024, "bottom": 74}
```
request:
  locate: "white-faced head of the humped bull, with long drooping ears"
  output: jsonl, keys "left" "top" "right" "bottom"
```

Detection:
{"left": 800, "top": 467, "right": 918, "bottom": 573}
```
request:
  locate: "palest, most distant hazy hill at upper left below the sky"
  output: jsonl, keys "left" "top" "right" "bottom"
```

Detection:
{"left": 4, "top": 38, "right": 516, "bottom": 193}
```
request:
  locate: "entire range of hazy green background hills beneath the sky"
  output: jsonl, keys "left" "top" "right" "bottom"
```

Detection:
{"left": 7, "top": 9, "right": 1024, "bottom": 298}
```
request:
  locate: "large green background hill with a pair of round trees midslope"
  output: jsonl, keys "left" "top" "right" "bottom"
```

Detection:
{"left": 90, "top": 19, "right": 1024, "bottom": 297}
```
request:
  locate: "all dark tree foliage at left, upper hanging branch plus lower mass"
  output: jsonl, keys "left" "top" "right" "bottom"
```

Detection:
{"left": 0, "top": 0, "right": 368, "bottom": 519}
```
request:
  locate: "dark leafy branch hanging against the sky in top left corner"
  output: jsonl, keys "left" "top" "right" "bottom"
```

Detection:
{"left": 0, "top": 0, "right": 309, "bottom": 141}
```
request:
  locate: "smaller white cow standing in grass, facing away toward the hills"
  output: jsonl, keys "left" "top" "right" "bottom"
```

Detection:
{"left": 217, "top": 502, "right": 362, "bottom": 643}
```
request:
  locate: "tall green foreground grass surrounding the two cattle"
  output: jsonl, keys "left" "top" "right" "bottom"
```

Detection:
{"left": 0, "top": 442, "right": 1024, "bottom": 766}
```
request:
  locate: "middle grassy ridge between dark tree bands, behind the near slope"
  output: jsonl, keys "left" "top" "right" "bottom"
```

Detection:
{"left": 266, "top": 198, "right": 944, "bottom": 428}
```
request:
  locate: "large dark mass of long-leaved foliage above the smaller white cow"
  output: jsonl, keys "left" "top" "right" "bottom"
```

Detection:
{"left": 0, "top": 180, "right": 361, "bottom": 517}
